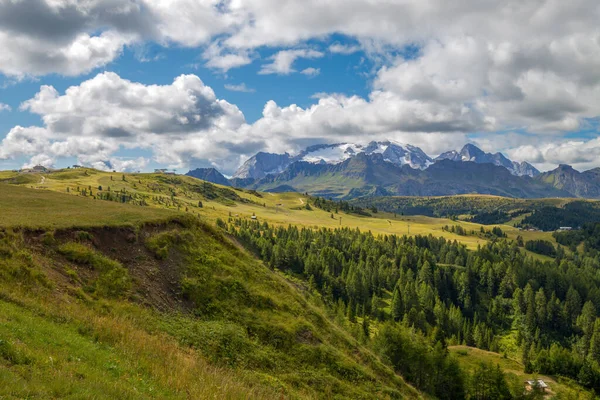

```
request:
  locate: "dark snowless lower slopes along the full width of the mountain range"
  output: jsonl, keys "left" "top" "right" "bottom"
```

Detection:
{"left": 188, "top": 157, "right": 600, "bottom": 199}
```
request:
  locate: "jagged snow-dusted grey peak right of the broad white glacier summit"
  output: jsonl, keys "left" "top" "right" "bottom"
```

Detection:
{"left": 436, "top": 144, "right": 540, "bottom": 177}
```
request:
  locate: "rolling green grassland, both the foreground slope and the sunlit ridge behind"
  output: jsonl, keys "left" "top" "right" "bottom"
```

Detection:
{"left": 0, "top": 170, "right": 582, "bottom": 398}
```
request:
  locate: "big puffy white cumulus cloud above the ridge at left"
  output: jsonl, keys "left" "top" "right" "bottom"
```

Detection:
{"left": 0, "top": 72, "right": 252, "bottom": 173}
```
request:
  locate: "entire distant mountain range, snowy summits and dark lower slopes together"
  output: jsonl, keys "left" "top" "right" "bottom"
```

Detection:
{"left": 187, "top": 141, "right": 600, "bottom": 199}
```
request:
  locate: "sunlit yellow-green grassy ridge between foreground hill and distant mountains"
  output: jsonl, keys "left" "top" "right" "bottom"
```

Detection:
{"left": 0, "top": 169, "right": 561, "bottom": 249}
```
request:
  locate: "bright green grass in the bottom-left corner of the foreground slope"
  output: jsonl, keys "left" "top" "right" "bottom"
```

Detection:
{"left": 0, "top": 293, "right": 275, "bottom": 399}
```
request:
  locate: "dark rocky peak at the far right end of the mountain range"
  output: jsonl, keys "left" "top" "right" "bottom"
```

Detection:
{"left": 536, "top": 164, "right": 600, "bottom": 198}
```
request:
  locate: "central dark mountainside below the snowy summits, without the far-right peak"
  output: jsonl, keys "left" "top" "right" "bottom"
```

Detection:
{"left": 246, "top": 153, "right": 572, "bottom": 198}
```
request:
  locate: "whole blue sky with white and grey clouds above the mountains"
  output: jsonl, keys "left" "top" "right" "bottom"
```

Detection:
{"left": 0, "top": 0, "right": 600, "bottom": 175}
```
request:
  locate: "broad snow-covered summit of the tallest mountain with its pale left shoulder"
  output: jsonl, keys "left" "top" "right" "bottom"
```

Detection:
{"left": 233, "top": 140, "right": 433, "bottom": 179}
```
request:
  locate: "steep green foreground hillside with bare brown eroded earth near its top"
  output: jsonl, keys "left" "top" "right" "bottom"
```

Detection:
{"left": 0, "top": 186, "right": 419, "bottom": 399}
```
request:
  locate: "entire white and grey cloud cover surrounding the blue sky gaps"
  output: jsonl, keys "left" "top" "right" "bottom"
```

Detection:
{"left": 0, "top": 0, "right": 600, "bottom": 170}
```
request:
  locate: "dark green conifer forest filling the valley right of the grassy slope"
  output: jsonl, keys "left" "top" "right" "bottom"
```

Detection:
{"left": 226, "top": 219, "right": 600, "bottom": 399}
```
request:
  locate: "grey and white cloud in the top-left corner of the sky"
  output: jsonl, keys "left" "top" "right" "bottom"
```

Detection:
{"left": 0, "top": 0, "right": 232, "bottom": 77}
